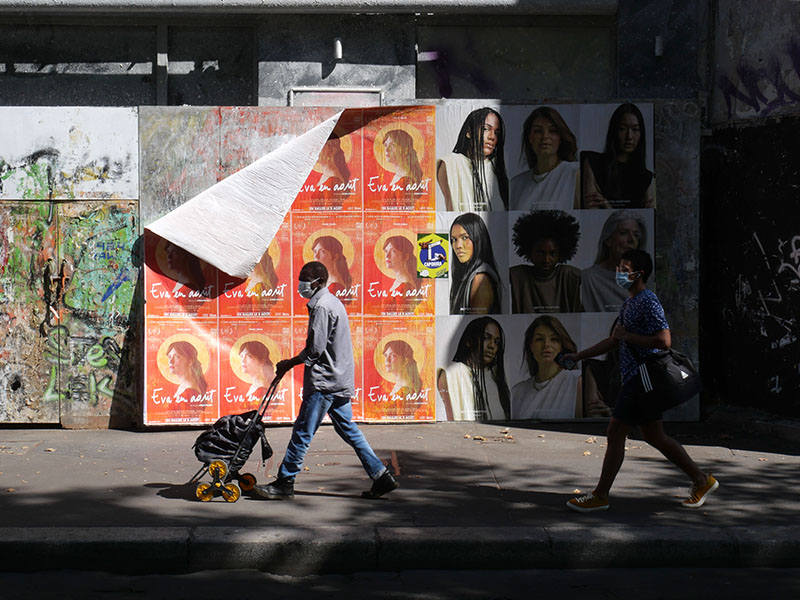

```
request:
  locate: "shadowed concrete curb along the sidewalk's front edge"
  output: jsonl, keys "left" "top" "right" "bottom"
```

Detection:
{"left": 6, "top": 524, "right": 800, "bottom": 575}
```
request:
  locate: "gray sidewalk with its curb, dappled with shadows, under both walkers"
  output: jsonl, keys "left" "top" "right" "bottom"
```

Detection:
{"left": 0, "top": 420, "right": 800, "bottom": 574}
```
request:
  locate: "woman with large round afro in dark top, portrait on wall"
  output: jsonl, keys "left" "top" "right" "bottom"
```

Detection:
{"left": 509, "top": 210, "right": 583, "bottom": 313}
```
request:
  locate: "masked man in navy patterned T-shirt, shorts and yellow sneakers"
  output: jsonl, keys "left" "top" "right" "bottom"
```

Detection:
{"left": 567, "top": 249, "right": 719, "bottom": 512}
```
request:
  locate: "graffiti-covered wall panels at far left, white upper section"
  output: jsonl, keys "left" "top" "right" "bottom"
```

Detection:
{"left": 0, "top": 107, "right": 139, "bottom": 427}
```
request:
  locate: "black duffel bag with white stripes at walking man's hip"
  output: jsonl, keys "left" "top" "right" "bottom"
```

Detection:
{"left": 637, "top": 349, "right": 700, "bottom": 412}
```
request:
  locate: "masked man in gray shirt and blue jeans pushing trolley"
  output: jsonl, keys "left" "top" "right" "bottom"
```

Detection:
{"left": 254, "top": 261, "right": 398, "bottom": 500}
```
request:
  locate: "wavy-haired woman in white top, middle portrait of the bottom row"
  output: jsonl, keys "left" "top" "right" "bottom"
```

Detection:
{"left": 511, "top": 315, "right": 583, "bottom": 419}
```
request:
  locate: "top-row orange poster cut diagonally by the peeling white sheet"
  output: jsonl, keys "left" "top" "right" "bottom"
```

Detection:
{"left": 292, "top": 110, "right": 364, "bottom": 211}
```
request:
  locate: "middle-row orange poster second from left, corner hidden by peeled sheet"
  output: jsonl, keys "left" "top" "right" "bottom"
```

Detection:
{"left": 219, "top": 215, "right": 293, "bottom": 317}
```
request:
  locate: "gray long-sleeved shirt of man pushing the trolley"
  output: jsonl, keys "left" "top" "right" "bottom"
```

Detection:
{"left": 298, "top": 287, "right": 356, "bottom": 398}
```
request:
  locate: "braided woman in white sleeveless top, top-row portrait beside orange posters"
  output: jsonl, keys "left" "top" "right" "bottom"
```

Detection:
{"left": 436, "top": 107, "right": 508, "bottom": 212}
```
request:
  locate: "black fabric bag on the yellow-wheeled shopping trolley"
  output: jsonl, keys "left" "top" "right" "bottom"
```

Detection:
{"left": 193, "top": 410, "right": 272, "bottom": 473}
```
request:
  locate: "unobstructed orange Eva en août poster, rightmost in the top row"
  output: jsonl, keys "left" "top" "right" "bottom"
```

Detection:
{"left": 363, "top": 106, "right": 436, "bottom": 210}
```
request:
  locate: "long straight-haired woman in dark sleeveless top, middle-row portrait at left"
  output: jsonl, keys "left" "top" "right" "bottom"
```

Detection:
{"left": 450, "top": 213, "right": 503, "bottom": 315}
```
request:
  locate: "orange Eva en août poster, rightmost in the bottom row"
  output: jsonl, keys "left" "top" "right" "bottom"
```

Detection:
{"left": 363, "top": 317, "right": 436, "bottom": 421}
